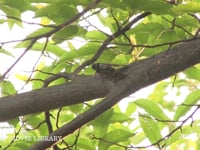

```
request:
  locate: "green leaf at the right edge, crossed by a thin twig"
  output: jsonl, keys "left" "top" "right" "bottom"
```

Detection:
{"left": 174, "top": 90, "right": 200, "bottom": 120}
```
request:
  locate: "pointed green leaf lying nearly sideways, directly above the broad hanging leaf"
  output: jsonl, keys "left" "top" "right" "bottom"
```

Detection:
{"left": 134, "top": 99, "right": 168, "bottom": 120}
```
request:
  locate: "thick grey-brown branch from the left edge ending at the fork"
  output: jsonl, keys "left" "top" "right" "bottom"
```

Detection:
{"left": 0, "top": 76, "right": 113, "bottom": 122}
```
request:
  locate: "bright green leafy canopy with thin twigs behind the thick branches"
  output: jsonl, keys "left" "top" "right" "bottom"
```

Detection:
{"left": 0, "top": 0, "right": 200, "bottom": 150}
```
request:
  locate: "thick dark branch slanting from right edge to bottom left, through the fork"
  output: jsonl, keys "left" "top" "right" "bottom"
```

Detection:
{"left": 31, "top": 39, "right": 200, "bottom": 150}
